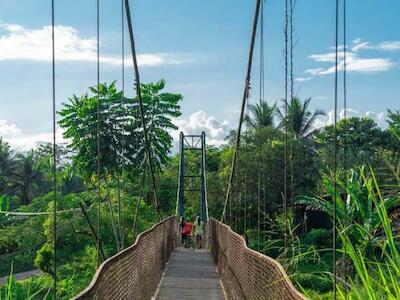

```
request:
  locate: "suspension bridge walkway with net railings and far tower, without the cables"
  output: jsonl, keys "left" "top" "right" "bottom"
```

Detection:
{"left": 75, "top": 132, "right": 303, "bottom": 300}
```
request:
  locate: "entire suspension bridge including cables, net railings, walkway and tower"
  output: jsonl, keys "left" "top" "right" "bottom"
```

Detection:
{"left": 2, "top": 0, "right": 350, "bottom": 299}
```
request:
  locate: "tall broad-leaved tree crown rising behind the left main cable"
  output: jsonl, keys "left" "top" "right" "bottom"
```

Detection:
{"left": 59, "top": 80, "right": 182, "bottom": 178}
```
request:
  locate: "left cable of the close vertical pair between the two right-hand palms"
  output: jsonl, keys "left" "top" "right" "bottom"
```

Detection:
{"left": 283, "top": 0, "right": 289, "bottom": 253}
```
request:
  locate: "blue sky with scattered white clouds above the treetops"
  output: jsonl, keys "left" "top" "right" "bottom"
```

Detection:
{"left": 0, "top": 0, "right": 400, "bottom": 149}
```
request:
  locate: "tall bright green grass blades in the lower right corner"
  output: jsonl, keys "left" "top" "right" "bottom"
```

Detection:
{"left": 338, "top": 168, "right": 400, "bottom": 300}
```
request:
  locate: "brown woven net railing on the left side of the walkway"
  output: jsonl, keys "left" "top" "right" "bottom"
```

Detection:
{"left": 74, "top": 216, "right": 179, "bottom": 299}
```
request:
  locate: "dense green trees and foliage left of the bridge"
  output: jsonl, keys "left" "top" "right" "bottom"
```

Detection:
{"left": 0, "top": 81, "right": 182, "bottom": 299}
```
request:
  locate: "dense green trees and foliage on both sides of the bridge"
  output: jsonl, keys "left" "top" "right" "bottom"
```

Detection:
{"left": 0, "top": 86, "right": 400, "bottom": 299}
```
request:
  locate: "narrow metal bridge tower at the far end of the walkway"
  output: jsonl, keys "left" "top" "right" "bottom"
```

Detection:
{"left": 176, "top": 131, "right": 208, "bottom": 222}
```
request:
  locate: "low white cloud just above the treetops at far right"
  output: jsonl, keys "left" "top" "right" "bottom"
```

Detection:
{"left": 314, "top": 108, "right": 387, "bottom": 128}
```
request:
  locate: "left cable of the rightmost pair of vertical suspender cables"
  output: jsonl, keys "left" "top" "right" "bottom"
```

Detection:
{"left": 332, "top": 0, "right": 339, "bottom": 299}
